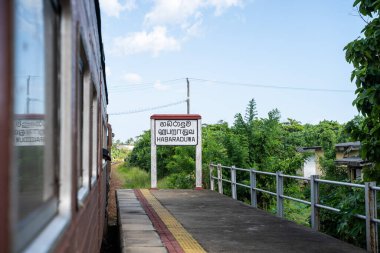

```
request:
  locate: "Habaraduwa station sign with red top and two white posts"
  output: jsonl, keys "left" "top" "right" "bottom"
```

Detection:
{"left": 150, "top": 114, "right": 202, "bottom": 189}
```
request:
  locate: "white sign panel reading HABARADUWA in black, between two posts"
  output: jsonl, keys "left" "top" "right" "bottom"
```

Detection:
{"left": 154, "top": 120, "right": 198, "bottom": 146}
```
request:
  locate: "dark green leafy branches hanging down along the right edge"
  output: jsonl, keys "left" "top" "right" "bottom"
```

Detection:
{"left": 344, "top": 0, "right": 380, "bottom": 181}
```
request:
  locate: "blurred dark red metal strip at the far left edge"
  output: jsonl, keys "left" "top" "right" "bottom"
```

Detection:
{"left": 0, "top": 1, "right": 13, "bottom": 252}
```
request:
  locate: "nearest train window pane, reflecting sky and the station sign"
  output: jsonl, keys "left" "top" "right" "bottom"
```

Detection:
{"left": 12, "top": 0, "right": 60, "bottom": 251}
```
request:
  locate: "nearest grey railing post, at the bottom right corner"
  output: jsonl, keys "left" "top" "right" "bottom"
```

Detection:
{"left": 365, "top": 182, "right": 378, "bottom": 253}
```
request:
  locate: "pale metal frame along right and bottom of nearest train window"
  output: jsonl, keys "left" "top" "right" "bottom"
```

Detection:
{"left": 12, "top": 0, "right": 72, "bottom": 253}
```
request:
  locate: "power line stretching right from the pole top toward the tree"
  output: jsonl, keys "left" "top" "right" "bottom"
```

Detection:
{"left": 189, "top": 78, "right": 355, "bottom": 93}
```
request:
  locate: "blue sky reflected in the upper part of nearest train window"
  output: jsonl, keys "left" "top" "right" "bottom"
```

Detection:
{"left": 14, "top": 1, "right": 45, "bottom": 114}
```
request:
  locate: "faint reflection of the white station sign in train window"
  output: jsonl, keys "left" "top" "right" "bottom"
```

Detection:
{"left": 14, "top": 119, "right": 45, "bottom": 146}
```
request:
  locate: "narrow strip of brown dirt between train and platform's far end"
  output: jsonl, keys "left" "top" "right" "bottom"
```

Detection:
{"left": 107, "top": 163, "right": 123, "bottom": 226}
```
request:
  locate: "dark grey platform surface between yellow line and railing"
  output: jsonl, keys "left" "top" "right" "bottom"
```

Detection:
{"left": 151, "top": 190, "right": 365, "bottom": 253}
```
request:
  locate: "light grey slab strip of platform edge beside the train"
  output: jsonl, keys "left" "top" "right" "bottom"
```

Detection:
{"left": 116, "top": 190, "right": 167, "bottom": 253}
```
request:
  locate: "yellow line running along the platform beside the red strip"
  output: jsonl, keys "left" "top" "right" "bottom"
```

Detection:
{"left": 141, "top": 189, "right": 206, "bottom": 253}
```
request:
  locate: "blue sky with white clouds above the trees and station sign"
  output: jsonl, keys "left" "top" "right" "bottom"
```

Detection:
{"left": 100, "top": 0, "right": 364, "bottom": 140}
